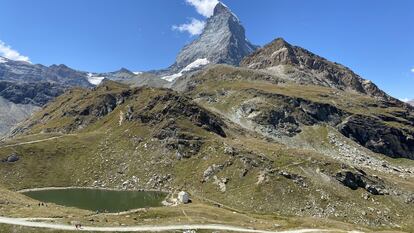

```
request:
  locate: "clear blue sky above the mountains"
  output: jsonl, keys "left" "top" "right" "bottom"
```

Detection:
{"left": 0, "top": 0, "right": 414, "bottom": 99}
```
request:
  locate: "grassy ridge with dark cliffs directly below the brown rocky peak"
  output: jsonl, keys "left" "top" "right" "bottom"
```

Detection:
{"left": 174, "top": 63, "right": 414, "bottom": 159}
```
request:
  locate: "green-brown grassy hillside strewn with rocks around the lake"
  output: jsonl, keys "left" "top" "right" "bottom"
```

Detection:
{"left": 0, "top": 79, "right": 414, "bottom": 231}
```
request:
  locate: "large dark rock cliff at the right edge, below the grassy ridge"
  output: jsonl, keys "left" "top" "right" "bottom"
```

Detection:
{"left": 338, "top": 115, "right": 414, "bottom": 159}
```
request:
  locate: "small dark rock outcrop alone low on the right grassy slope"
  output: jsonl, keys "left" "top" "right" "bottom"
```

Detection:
{"left": 335, "top": 170, "right": 389, "bottom": 195}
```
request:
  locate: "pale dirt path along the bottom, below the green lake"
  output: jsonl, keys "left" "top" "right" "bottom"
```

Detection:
{"left": 0, "top": 217, "right": 340, "bottom": 233}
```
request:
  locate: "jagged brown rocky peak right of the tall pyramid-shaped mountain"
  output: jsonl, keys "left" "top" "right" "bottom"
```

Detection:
{"left": 240, "top": 38, "right": 402, "bottom": 102}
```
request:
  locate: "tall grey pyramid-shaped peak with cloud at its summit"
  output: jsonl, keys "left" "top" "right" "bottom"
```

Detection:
{"left": 171, "top": 3, "right": 257, "bottom": 71}
